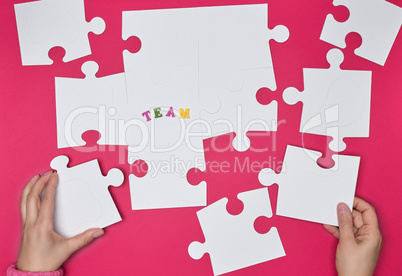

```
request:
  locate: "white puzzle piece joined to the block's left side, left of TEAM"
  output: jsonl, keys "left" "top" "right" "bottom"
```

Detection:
{"left": 55, "top": 61, "right": 130, "bottom": 148}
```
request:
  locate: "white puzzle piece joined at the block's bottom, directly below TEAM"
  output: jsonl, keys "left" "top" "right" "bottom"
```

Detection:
{"left": 129, "top": 138, "right": 207, "bottom": 210}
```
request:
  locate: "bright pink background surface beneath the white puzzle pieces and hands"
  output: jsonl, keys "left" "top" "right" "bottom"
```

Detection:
{"left": 0, "top": 0, "right": 402, "bottom": 275}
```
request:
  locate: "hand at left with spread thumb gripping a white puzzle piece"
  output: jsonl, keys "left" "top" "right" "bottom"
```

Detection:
{"left": 17, "top": 171, "right": 104, "bottom": 272}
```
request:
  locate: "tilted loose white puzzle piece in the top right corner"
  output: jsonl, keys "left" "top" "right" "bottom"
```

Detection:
{"left": 320, "top": 0, "right": 402, "bottom": 65}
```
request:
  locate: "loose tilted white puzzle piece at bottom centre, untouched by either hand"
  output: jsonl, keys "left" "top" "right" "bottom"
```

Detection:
{"left": 188, "top": 188, "right": 286, "bottom": 275}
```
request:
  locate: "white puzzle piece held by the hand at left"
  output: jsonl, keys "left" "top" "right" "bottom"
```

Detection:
{"left": 50, "top": 155, "right": 124, "bottom": 238}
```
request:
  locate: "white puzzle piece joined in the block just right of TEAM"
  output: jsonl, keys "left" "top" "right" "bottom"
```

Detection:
{"left": 200, "top": 68, "right": 278, "bottom": 151}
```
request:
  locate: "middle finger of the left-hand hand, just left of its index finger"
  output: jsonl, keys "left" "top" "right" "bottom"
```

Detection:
{"left": 26, "top": 171, "right": 53, "bottom": 223}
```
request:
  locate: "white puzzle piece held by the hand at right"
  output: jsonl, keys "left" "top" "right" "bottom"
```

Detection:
{"left": 258, "top": 146, "right": 360, "bottom": 226}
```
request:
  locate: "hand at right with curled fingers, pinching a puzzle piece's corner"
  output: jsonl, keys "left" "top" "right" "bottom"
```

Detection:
{"left": 324, "top": 197, "right": 382, "bottom": 276}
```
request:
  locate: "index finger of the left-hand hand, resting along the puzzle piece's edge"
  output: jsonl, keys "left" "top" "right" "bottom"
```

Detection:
{"left": 38, "top": 173, "right": 59, "bottom": 225}
